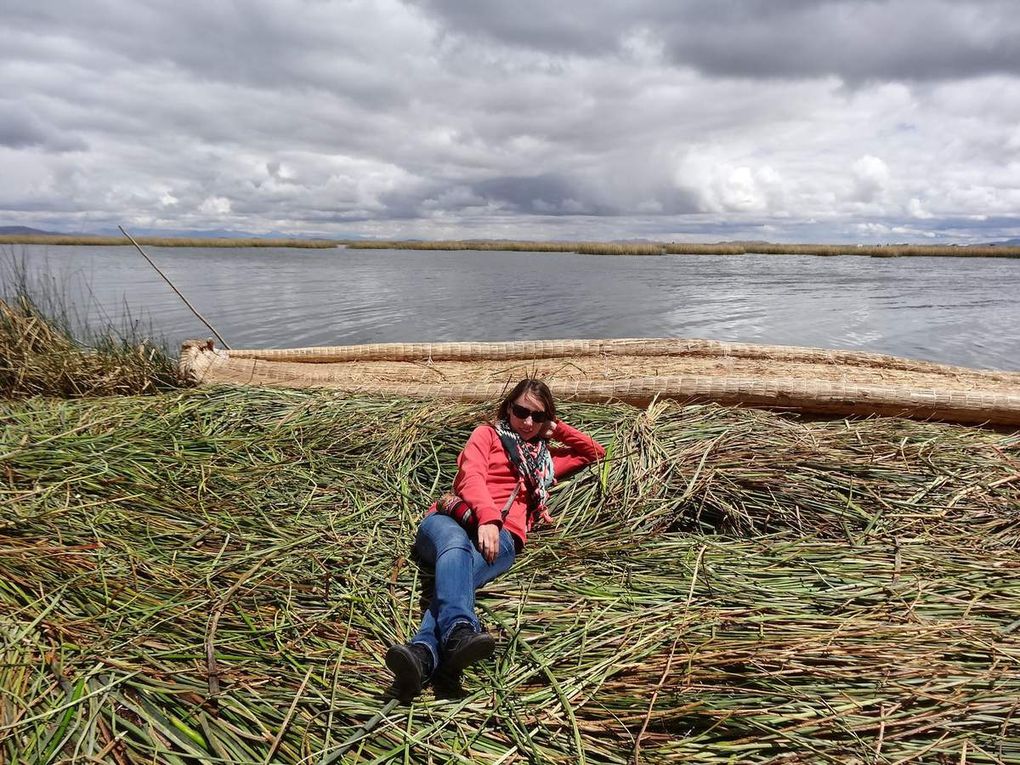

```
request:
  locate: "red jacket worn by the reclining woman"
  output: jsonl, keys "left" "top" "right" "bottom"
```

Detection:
{"left": 453, "top": 420, "right": 606, "bottom": 545}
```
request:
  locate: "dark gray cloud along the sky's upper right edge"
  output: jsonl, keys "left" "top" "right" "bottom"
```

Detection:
{"left": 420, "top": 0, "right": 1020, "bottom": 82}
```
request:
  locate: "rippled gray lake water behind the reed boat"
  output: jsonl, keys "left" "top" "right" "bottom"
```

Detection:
{"left": 0, "top": 246, "right": 1020, "bottom": 369}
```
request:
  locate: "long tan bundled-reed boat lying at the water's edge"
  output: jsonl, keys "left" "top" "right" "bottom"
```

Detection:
{"left": 181, "top": 338, "right": 1020, "bottom": 426}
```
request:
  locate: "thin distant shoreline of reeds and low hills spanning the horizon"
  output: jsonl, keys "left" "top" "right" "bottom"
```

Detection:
{"left": 0, "top": 234, "right": 1020, "bottom": 258}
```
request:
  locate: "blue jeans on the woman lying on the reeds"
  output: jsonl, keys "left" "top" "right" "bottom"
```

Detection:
{"left": 411, "top": 513, "right": 516, "bottom": 668}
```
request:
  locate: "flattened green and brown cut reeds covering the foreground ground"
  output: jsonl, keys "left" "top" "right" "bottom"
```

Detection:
{"left": 0, "top": 389, "right": 1020, "bottom": 765}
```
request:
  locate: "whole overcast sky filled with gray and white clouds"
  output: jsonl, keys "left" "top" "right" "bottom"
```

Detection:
{"left": 0, "top": 0, "right": 1020, "bottom": 243}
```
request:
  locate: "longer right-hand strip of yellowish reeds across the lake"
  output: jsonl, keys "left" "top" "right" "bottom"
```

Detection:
{"left": 346, "top": 240, "right": 1020, "bottom": 258}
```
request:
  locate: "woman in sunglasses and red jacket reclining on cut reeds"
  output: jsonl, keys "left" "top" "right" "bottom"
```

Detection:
{"left": 386, "top": 378, "right": 606, "bottom": 697}
